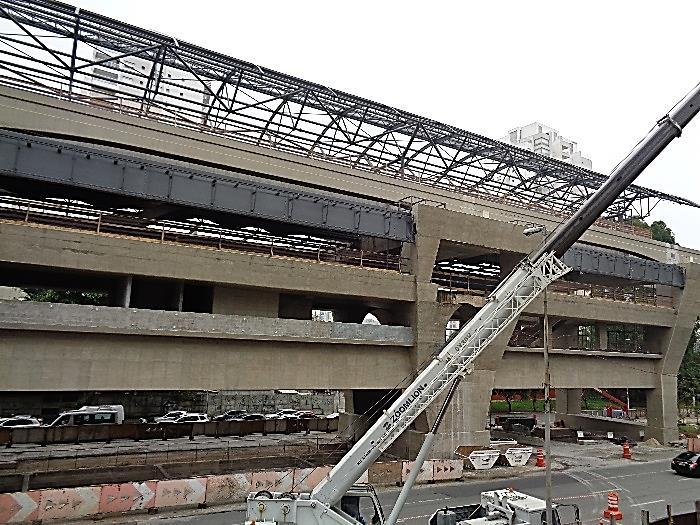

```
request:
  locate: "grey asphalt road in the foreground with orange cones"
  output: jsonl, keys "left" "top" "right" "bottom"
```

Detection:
{"left": 133, "top": 460, "right": 700, "bottom": 525}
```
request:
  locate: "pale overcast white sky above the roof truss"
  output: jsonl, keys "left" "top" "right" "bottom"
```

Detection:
{"left": 72, "top": 0, "right": 700, "bottom": 249}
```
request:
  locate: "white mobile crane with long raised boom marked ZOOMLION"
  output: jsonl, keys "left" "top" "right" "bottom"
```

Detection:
{"left": 246, "top": 84, "right": 700, "bottom": 525}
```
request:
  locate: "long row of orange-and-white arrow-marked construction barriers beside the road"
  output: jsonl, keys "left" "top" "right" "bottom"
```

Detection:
{"left": 0, "top": 450, "right": 499, "bottom": 524}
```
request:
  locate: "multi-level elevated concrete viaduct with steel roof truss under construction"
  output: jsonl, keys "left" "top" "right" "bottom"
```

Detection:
{"left": 0, "top": 2, "right": 700, "bottom": 456}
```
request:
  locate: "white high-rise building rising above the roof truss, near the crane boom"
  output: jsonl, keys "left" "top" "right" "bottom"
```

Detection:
{"left": 499, "top": 122, "right": 593, "bottom": 169}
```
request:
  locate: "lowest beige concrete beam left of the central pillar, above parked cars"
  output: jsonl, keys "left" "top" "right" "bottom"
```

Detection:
{"left": 0, "top": 330, "right": 411, "bottom": 391}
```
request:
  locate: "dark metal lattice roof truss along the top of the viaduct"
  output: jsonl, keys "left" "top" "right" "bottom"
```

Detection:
{"left": 0, "top": 0, "right": 698, "bottom": 218}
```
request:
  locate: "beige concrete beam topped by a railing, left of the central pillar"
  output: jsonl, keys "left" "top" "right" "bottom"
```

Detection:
{"left": 0, "top": 222, "right": 414, "bottom": 301}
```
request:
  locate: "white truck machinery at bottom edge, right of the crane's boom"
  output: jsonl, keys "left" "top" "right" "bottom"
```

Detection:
{"left": 429, "top": 489, "right": 581, "bottom": 525}
